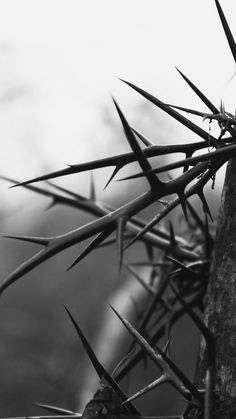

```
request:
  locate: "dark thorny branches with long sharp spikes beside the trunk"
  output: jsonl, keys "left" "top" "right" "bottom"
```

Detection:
{"left": 0, "top": 0, "right": 236, "bottom": 419}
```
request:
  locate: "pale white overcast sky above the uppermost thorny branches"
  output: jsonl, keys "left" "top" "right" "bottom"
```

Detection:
{"left": 0, "top": 0, "right": 236, "bottom": 213}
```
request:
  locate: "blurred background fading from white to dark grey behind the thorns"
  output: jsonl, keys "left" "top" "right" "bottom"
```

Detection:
{"left": 0, "top": 0, "right": 236, "bottom": 416}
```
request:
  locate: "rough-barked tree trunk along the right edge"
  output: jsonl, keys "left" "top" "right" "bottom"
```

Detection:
{"left": 197, "top": 157, "right": 236, "bottom": 419}
